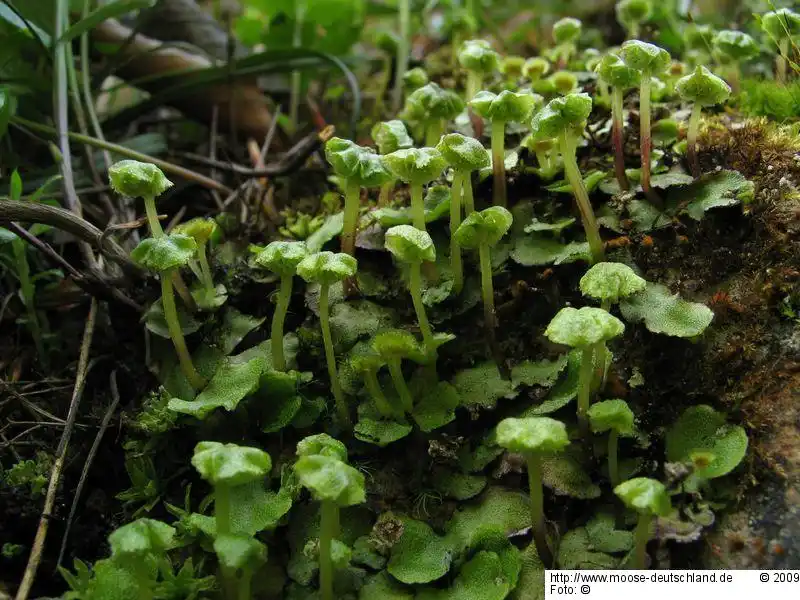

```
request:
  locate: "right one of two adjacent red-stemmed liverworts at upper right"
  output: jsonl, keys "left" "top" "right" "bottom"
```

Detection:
{"left": 620, "top": 40, "right": 670, "bottom": 202}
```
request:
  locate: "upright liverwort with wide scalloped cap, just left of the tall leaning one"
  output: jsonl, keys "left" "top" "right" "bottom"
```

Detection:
{"left": 469, "top": 90, "right": 538, "bottom": 206}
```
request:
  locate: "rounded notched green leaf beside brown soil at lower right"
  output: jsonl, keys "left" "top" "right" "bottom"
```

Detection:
{"left": 667, "top": 404, "right": 747, "bottom": 479}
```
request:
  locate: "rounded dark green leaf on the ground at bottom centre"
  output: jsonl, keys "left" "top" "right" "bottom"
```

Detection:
{"left": 386, "top": 519, "right": 453, "bottom": 584}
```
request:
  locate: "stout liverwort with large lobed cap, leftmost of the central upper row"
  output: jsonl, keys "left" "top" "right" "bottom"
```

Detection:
{"left": 325, "top": 137, "right": 391, "bottom": 256}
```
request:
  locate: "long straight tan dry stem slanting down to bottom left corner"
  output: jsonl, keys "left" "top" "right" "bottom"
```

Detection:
{"left": 15, "top": 298, "right": 98, "bottom": 600}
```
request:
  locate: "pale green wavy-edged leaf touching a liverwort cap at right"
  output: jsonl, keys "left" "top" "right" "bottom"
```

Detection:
{"left": 619, "top": 282, "right": 714, "bottom": 338}
